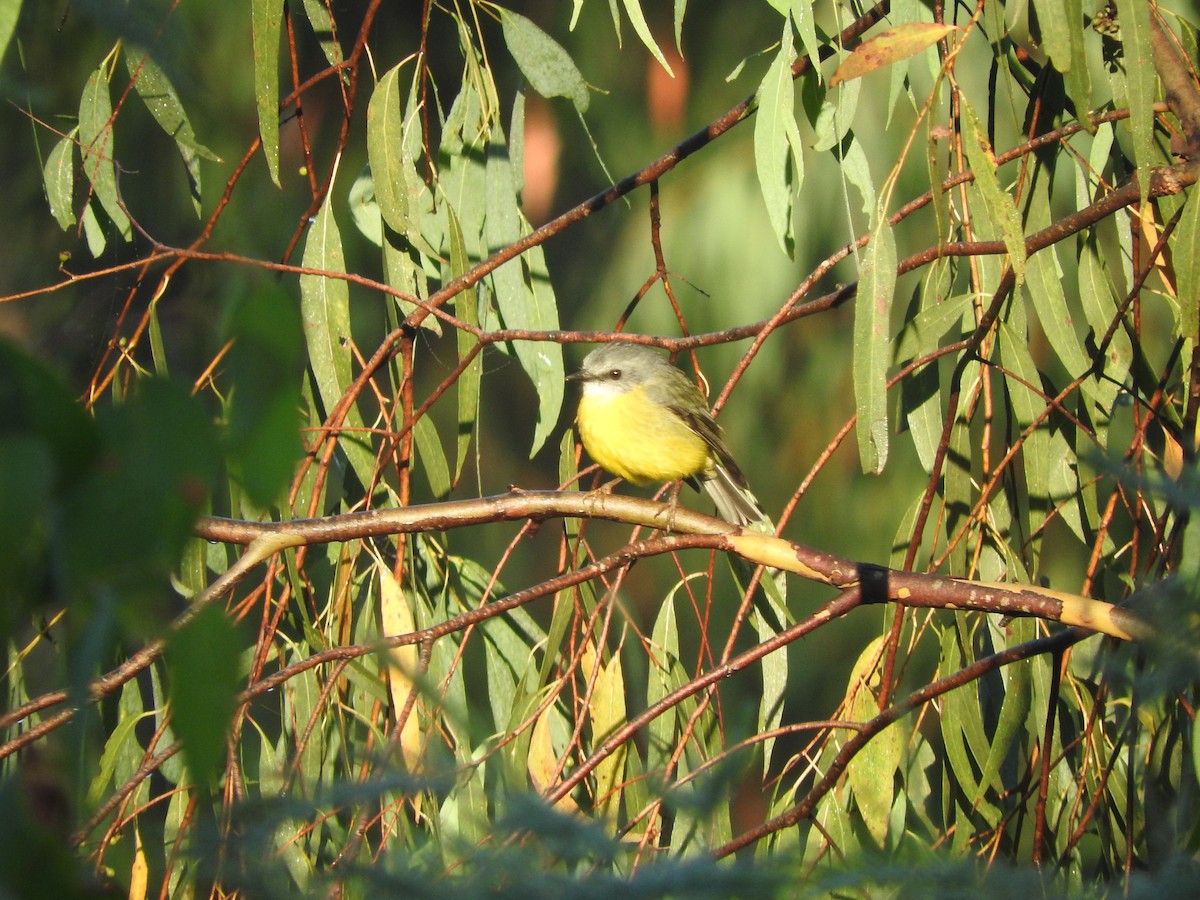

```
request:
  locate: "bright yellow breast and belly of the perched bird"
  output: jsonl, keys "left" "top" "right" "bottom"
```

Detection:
{"left": 580, "top": 388, "right": 710, "bottom": 485}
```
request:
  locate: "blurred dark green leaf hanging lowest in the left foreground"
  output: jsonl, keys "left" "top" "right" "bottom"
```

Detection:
{"left": 166, "top": 606, "right": 241, "bottom": 788}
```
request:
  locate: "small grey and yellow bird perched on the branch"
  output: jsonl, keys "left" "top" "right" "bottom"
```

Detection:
{"left": 566, "top": 342, "right": 769, "bottom": 528}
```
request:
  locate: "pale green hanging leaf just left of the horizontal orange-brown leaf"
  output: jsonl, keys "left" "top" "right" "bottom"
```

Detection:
{"left": 754, "top": 20, "right": 804, "bottom": 257}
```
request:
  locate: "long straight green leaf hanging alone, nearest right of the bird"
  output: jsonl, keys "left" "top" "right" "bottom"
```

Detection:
{"left": 853, "top": 209, "right": 896, "bottom": 474}
